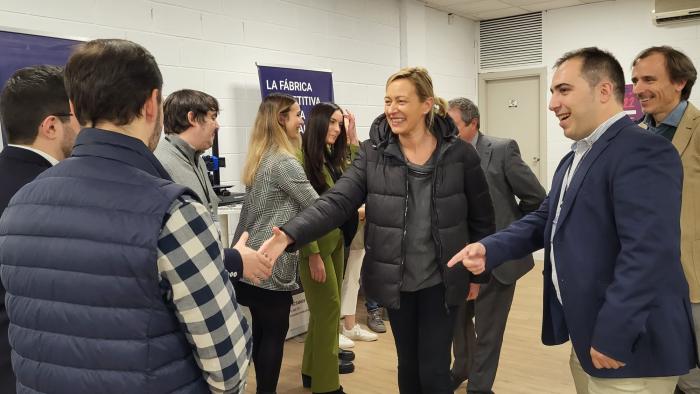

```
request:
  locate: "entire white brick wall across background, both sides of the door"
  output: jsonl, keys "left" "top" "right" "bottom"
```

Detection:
{"left": 0, "top": 0, "right": 700, "bottom": 191}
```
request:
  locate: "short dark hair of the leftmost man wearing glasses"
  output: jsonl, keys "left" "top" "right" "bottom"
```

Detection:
{"left": 0, "top": 66, "right": 70, "bottom": 145}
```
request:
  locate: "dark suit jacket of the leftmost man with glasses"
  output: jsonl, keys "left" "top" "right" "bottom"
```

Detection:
{"left": 0, "top": 146, "right": 51, "bottom": 393}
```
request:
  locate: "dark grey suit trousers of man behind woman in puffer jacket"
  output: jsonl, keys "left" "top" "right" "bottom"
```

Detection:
{"left": 452, "top": 277, "right": 515, "bottom": 394}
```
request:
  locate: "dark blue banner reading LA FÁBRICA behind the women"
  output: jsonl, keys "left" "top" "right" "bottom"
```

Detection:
{"left": 258, "top": 65, "right": 333, "bottom": 131}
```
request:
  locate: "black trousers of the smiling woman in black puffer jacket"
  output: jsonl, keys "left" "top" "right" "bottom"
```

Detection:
{"left": 389, "top": 284, "right": 457, "bottom": 394}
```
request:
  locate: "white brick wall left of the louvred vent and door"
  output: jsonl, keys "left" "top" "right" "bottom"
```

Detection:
{"left": 0, "top": 0, "right": 475, "bottom": 188}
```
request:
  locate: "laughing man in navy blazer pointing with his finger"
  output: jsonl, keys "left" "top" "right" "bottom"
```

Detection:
{"left": 450, "top": 48, "right": 697, "bottom": 393}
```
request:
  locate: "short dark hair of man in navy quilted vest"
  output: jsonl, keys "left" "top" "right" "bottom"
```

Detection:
{"left": 65, "top": 39, "right": 163, "bottom": 127}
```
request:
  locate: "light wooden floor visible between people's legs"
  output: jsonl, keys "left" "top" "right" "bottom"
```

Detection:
{"left": 246, "top": 263, "right": 575, "bottom": 394}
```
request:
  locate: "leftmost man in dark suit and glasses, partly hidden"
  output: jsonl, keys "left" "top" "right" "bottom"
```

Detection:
{"left": 0, "top": 66, "right": 80, "bottom": 393}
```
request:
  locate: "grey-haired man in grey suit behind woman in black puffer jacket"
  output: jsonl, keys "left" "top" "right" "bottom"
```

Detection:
{"left": 448, "top": 97, "right": 546, "bottom": 393}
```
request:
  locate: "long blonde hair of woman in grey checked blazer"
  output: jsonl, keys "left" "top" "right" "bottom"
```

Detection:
{"left": 243, "top": 93, "right": 298, "bottom": 186}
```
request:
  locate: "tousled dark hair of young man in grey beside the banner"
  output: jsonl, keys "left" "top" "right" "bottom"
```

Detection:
{"left": 163, "top": 89, "right": 219, "bottom": 134}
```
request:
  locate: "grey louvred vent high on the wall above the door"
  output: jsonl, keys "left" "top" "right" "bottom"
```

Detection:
{"left": 479, "top": 12, "right": 542, "bottom": 71}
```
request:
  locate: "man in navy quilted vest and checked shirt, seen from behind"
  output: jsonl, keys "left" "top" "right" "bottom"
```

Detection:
{"left": 0, "top": 40, "right": 261, "bottom": 394}
